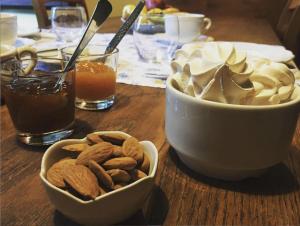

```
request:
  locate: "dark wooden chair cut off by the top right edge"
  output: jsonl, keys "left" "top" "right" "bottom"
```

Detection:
{"left": 275, "top": 0, "right": 300, "bottom": 66}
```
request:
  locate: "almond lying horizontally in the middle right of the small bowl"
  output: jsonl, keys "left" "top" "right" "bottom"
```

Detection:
{"left": 102, "top": 157, "right": 137, "bottom": 170}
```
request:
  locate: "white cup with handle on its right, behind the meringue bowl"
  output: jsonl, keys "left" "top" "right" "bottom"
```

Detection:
{"left": 165, "top": 13, "right": 212, "bottom": 44}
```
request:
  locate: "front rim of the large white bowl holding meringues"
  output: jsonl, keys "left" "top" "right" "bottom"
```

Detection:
{"left": 166, "top": 75, "right": 300, "bottom": 111}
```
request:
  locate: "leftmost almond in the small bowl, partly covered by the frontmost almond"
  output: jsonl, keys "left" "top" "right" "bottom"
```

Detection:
{"left": 47, "top": 158, "right": 76, "bottom": 188}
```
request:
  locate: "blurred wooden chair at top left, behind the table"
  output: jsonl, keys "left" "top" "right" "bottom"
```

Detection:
{"left": 32, "top": 0, "right": 89, "bottom": 29}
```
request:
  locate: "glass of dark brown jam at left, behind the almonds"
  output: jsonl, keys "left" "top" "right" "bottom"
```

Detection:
{"left": 1, "top": 58, "right": 75, "bottom": 145}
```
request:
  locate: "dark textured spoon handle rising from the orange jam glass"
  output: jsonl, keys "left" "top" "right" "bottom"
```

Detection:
{"left": 105, "top": 0, "right": 145, "bottom": 54}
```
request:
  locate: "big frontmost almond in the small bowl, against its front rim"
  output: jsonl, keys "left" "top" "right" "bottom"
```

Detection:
{"left": 64, "top": 165, "right": 99, "bottom": 199}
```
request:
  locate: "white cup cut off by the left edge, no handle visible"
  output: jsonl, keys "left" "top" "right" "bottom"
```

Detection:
{"left": 0, "top": 13, "right": 18, "bottom": 45}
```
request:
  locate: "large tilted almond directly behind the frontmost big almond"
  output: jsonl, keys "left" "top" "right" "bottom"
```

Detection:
{"left": 76, "top": 142, "right": 113, "bottom": 166}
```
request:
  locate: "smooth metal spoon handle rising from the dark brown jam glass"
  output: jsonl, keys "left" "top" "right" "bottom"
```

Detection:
{"left": 64, "top": 0, "right": 112, "bottom": 71}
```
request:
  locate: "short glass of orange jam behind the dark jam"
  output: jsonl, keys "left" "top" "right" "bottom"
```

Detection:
{"left": 62, "top": 44, "right": 118, "bottom": 110}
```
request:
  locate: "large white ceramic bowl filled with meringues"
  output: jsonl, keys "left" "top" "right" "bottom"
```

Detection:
{"left": 165, "top": 76, "right": 300, "bottom": 180}
